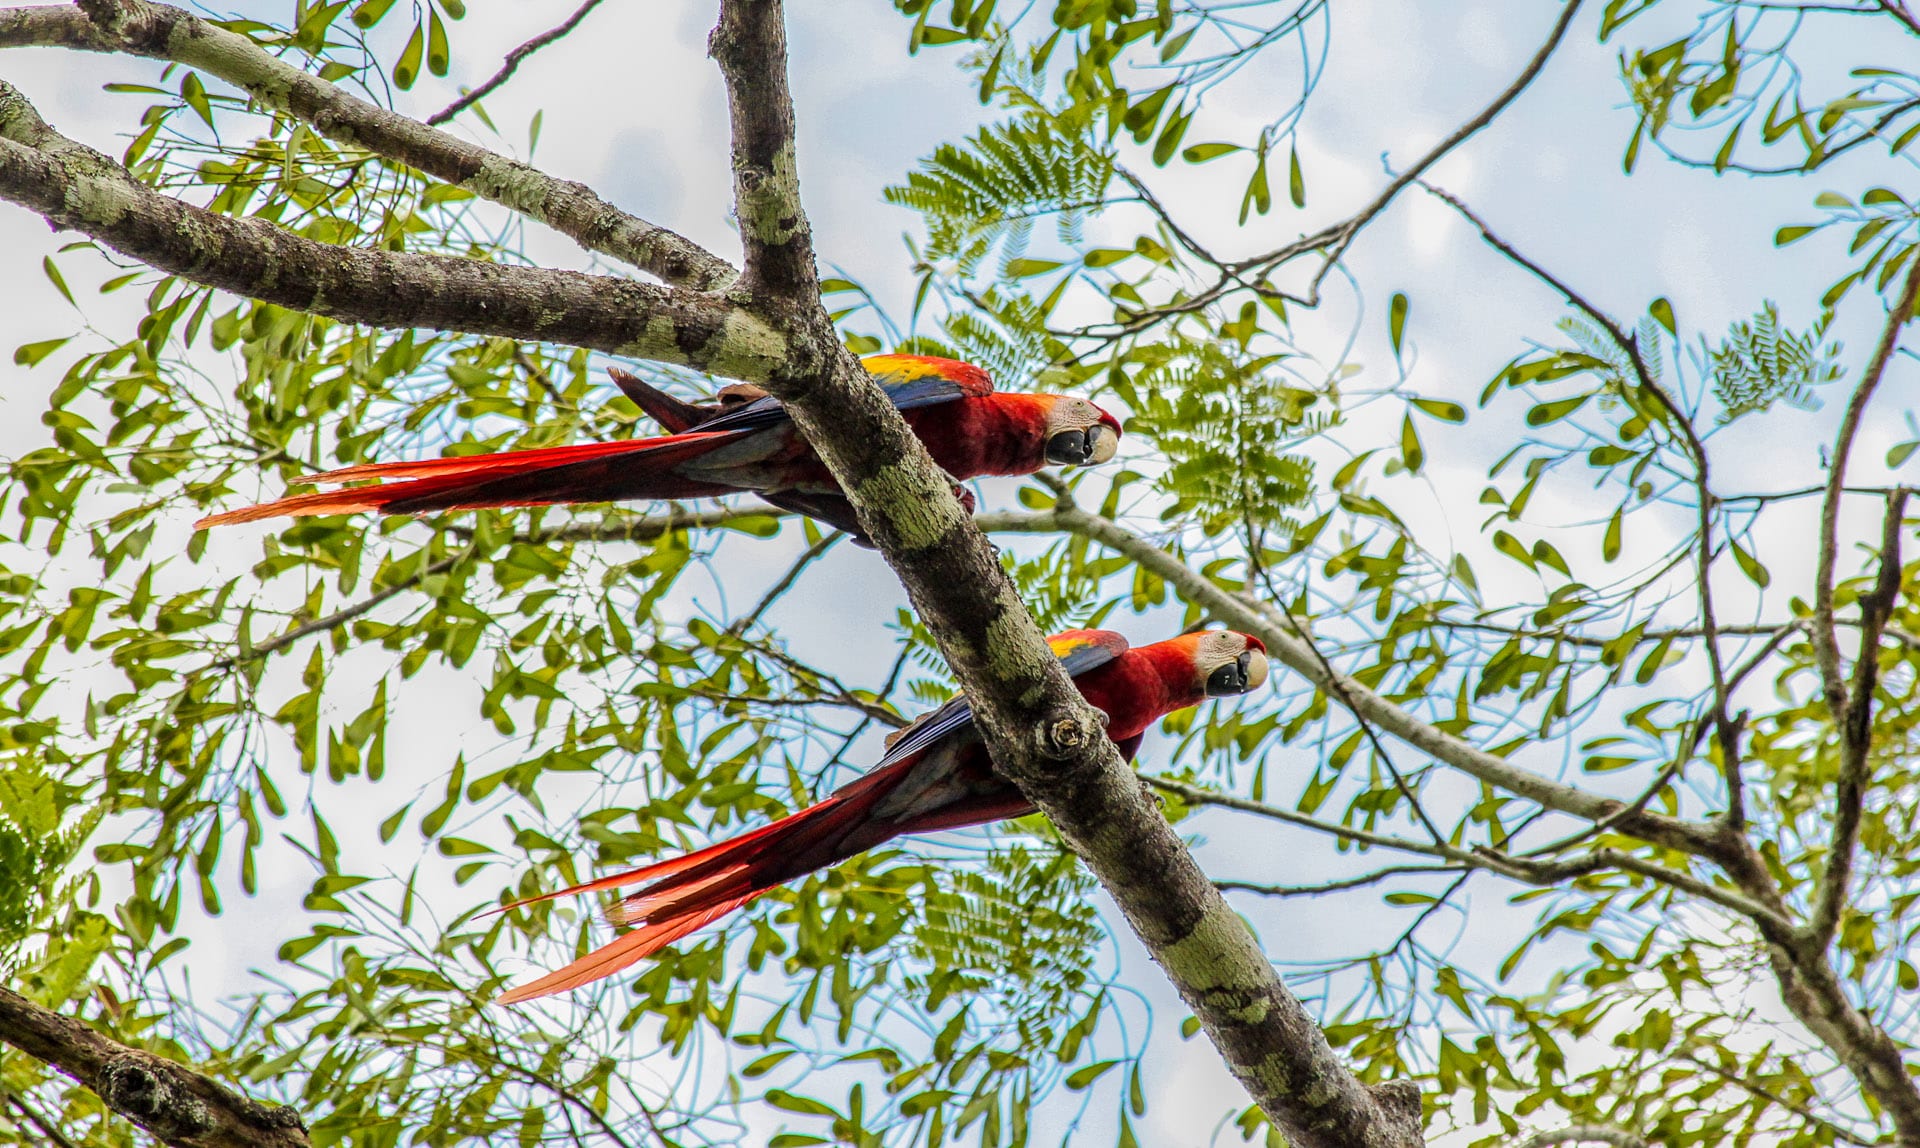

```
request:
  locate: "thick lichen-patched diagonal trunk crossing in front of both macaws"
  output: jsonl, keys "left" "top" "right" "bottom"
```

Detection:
{"left": 708, "top": 0, "right": 1421, "bottom": 1148}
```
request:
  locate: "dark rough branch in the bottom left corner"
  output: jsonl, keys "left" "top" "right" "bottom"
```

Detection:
{"left": 0, "top": 989, "right": 309, "bottom": 1148}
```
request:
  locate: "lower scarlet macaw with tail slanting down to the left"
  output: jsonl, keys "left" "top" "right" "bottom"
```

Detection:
{"left": 499, "top": 630, "right": 1267, "bottom": 1004}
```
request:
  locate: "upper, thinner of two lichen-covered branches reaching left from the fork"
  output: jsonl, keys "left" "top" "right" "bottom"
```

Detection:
{"left": 0, "top": 0, "right": 737, "bottom": 290}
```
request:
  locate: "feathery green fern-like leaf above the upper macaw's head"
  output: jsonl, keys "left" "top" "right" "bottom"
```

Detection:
{"left": 885, "top": 115, "right": 1114, "bottom": 275}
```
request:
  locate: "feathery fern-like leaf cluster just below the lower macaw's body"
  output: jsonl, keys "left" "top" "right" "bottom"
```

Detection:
{"left": 914, "top": 845, "right": 1102, "bottom": 1035}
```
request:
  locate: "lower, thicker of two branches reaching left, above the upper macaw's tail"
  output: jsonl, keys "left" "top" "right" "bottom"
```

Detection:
{"left": 0, "top": 81, "right": 785, "bottom": 366}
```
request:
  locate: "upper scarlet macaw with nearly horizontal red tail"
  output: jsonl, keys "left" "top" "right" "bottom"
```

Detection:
{"left": 194, "top": 355, "right": 1119, "bottom": 539}
